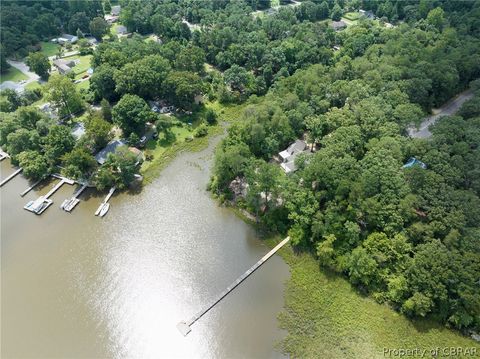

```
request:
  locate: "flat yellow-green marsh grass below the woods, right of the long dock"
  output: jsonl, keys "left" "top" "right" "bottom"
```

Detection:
{"left": 268, "top": 238, "right": 480, "bottom": 359}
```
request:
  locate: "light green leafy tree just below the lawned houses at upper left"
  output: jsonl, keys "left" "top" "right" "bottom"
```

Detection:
{"left": 45, "top": 75, "right": 83, "bottom": 117}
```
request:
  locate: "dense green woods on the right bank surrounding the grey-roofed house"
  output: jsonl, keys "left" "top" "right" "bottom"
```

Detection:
{"left": 211, "top": 2, "right": 480, "bottom": 330}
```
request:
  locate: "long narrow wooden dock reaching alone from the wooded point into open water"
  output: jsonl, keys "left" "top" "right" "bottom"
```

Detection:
{"left": 177, "top": 237, "right": 290, "bottom": 336}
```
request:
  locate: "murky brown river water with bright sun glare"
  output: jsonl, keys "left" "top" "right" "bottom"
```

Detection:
{"left": 0, "top": 138, "right": 289, "bottom": 358}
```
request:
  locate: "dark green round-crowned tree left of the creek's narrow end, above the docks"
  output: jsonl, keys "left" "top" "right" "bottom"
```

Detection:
{"left": 112, "top": 94, "right": 153, "bottom": 137}
